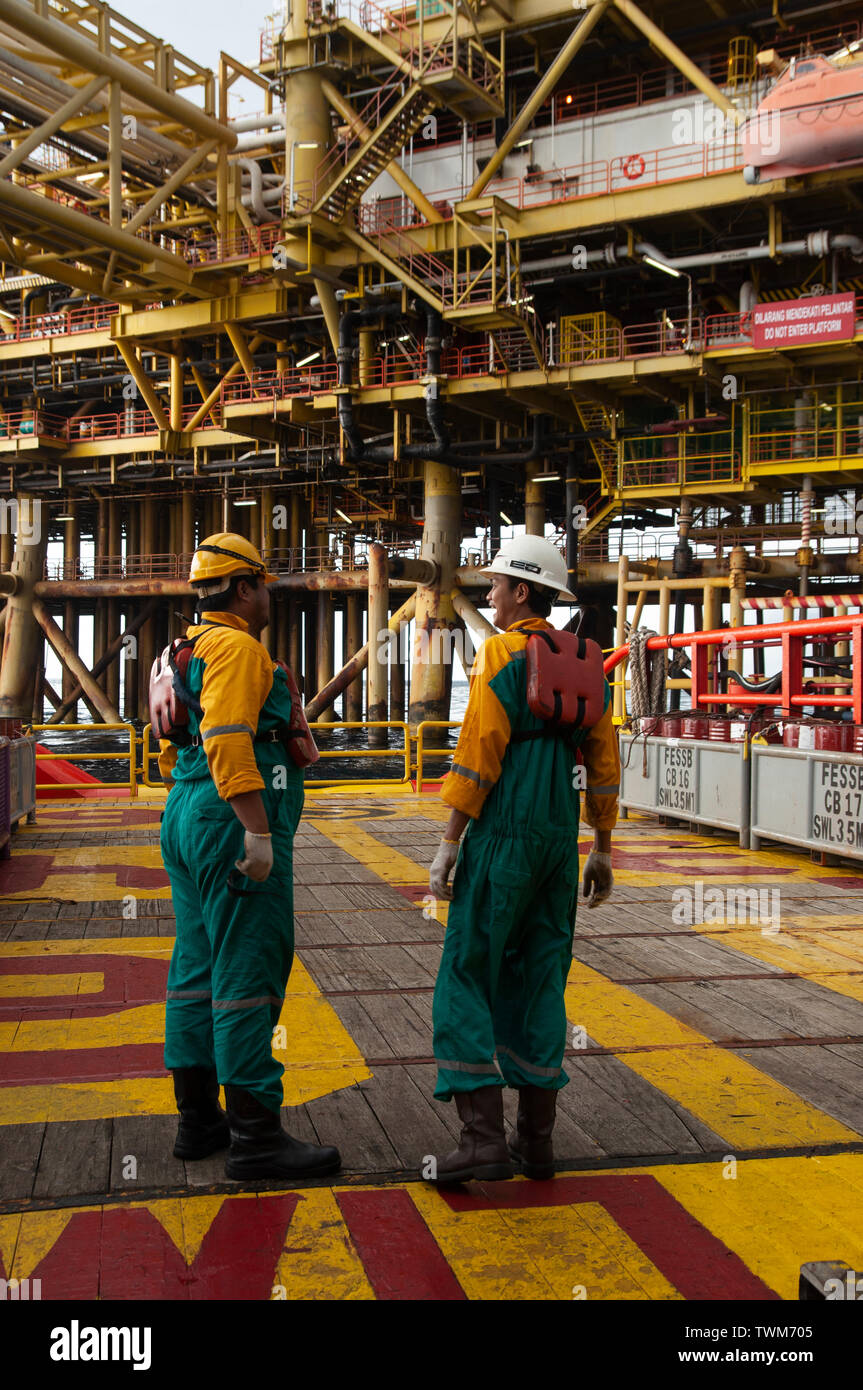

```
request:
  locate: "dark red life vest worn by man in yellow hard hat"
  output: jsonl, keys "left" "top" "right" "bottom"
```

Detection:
{"left": 149, "top": 624, "right": 321, "bottom": 767}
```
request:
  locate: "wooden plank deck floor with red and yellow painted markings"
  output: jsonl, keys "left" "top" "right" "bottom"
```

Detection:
{"left": 0, "top": 792, "right": 863, "bottom": 1300}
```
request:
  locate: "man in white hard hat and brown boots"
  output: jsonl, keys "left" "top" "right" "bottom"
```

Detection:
{"left": 424, "top": 535, "right": 620, "bottom": 1183}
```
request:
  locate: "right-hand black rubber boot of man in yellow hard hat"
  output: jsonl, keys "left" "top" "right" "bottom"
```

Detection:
{"left": 225, "top": 1086, "right": 342, "bottom": 1182}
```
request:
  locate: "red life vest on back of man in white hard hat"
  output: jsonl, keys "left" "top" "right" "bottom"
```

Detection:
{"left": 527, "top": 628, "right": 605, "bottom": 734}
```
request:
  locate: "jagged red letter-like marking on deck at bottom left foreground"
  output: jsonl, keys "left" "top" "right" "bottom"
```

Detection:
{"left": 15, "top": 1193, "right": 302, "bottom": 1301}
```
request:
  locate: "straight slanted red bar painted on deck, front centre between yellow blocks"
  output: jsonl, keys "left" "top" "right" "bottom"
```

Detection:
{"left": 336, "top": 1187, "right": 466, "bottom": 1301}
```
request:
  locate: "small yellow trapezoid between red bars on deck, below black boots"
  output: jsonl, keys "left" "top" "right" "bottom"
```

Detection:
{"left": 274, "top": 1187, "right": 374, "bottom": 1302}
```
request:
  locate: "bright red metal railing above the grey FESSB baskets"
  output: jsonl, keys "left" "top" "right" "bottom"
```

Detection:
{"left": 605, "top": 613, "right": 863, "bottom": 724}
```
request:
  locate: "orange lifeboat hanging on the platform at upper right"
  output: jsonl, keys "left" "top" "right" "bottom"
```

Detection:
{"left": 741, "top": 43, "right": 863, "bottom": 183}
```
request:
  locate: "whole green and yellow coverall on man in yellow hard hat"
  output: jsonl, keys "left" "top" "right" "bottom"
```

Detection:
{"left": 158, "top": 613, "right": 303, "bottom": 1111}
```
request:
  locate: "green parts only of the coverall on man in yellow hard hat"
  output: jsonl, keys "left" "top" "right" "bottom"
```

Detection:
{"left": 161, "top": 628, "right": 303, "bottom": 1111}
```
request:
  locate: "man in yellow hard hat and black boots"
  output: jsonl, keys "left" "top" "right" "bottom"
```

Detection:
{"left": 158, "top": 532, "right": 340, "bottom": 1179}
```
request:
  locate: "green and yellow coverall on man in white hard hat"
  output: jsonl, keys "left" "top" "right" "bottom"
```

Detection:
{"left": 434, "top": 617, "right": 620, "bottom": 1101}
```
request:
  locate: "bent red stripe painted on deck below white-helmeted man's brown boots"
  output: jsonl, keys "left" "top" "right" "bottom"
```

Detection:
{"left": 441, "top": 1173, "right": 780, "bottom": 1301}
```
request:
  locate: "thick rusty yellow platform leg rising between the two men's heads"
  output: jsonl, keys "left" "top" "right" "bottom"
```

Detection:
{"left": 408, "top": 460, "right": 461, "bottom": 726}
